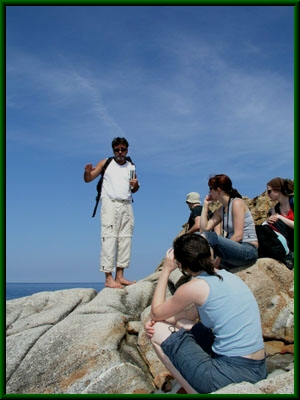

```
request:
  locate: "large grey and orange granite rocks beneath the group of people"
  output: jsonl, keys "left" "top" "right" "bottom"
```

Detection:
{"left": 6, "top": 258, "right": 294, "bottom": 394}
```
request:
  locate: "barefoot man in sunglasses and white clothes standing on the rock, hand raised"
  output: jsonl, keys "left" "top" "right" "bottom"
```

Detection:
{"left": 84, "top": 137, "right": 139, "bottom": 289}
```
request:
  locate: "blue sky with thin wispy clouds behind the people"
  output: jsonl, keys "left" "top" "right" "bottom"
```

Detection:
{"left": 6, "top": 5, "right": 294, "bottom": 282}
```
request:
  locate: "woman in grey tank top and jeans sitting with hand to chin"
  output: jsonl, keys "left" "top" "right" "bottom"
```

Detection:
{"left": 200, "top": 174, "right": 258, "bottom": 269}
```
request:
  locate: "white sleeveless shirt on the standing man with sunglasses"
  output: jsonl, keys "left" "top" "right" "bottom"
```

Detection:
{"left": 101, "top": 160, "right": 132, "bottom": 200}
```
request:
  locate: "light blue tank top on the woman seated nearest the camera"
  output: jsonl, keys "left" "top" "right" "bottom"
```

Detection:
{"left": 197, "top": 269, "right": 264, "bottom": 357}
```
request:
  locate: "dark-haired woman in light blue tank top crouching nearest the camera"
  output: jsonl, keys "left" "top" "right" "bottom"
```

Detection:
{"left": 145, "top": 234, "right": 267, "bottom": 394}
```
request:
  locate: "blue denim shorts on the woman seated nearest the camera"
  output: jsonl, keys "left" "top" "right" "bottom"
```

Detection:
{"left": 161, "top": 323, "right": 268, "bottom": 394}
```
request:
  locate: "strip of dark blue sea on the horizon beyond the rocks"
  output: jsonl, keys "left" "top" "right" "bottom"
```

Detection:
{"left": 6, "top": 282, "right": 104, "bottom": 300}
